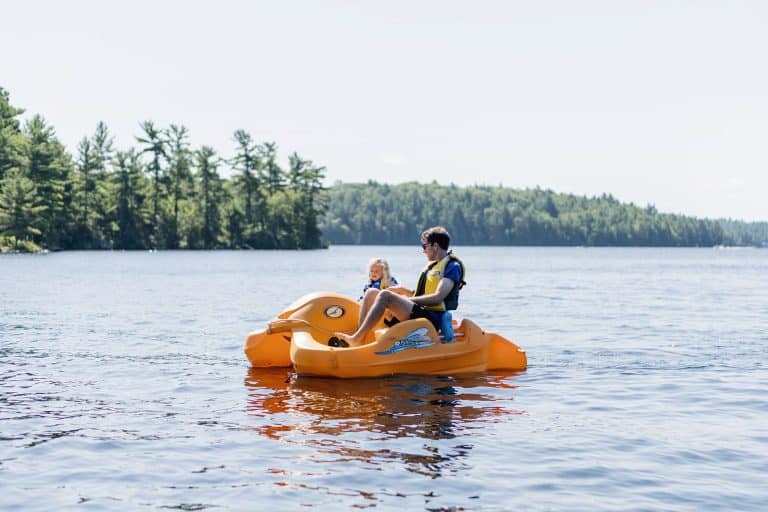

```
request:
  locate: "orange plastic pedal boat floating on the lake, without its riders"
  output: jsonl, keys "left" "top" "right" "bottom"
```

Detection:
{"left": 245, "top": 292, "right": 528, "bottom": 378}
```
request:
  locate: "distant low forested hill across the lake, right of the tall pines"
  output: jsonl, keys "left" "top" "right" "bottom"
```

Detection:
{"left": 319, "top": 181, "right": 768, "bottom": 247}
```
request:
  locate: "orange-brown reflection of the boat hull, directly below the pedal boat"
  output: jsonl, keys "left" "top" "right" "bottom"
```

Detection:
{"left": 245, "top": 368, "right": 523, "bottom": 439}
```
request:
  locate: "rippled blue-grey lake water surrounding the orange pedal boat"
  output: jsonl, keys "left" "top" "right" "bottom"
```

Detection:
{"left": 0, "top": 245, "right": 768, "bottom": 511}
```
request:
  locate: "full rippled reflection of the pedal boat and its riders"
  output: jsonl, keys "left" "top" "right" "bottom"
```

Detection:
{"left": 245, "top": 368, "right": 524, "bottom": 477}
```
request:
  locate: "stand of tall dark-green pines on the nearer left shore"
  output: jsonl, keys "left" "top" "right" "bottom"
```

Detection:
{"left": 0, "top": 87, "right": 325, "bottom": 251}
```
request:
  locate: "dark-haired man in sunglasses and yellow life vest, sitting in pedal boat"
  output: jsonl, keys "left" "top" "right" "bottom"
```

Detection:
{"left": 336, "top": 226, "right": 464, "bottom": 347}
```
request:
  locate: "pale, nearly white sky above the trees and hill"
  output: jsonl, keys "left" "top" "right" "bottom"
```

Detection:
{"left": 0, "top": 0, "right": 768, "bottom": 221}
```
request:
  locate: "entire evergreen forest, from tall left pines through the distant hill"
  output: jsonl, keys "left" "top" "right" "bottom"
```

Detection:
{"left": 0, "top": 88, "right": 768, "bottom": 252}
